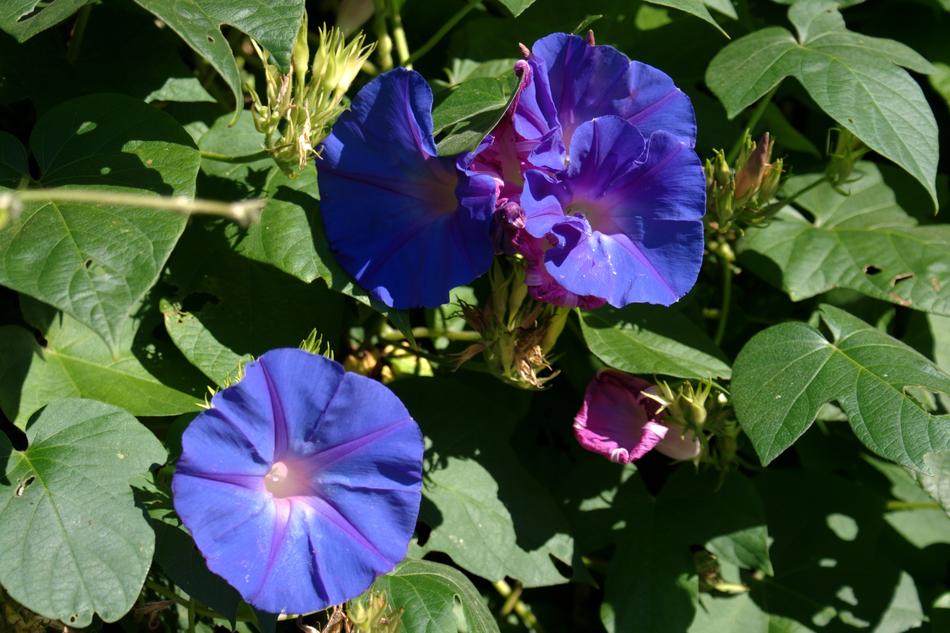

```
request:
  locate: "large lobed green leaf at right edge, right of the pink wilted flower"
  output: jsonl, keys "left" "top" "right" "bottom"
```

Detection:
{"left": 732, "top": 305, "right": 950, "bottom": 471}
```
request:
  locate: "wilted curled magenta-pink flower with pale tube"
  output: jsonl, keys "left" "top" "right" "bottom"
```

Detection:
{"left": 574, "top": 369, "right": 700, "bottom": 464}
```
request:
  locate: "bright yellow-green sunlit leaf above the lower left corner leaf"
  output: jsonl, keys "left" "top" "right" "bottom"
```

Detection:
{"left": 0, "top": 299, "right": 203, "bottom": 428}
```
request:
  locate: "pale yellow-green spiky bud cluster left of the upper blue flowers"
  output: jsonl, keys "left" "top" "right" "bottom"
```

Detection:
{"left": 246, "top": 17, "right": 374, "bottom": 178}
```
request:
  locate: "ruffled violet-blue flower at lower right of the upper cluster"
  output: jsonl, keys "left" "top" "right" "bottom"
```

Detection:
{"left": 521, "top": 116, "right": 706, "bottom": 307}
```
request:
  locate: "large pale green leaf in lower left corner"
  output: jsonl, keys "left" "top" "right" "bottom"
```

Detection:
{"left": 0, "top": 399, "right": 165, "bottom": 628}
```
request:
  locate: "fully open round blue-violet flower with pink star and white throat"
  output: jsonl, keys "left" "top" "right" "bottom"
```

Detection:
{"left": 172, "top": 349, "right": 423, "bottom": 613}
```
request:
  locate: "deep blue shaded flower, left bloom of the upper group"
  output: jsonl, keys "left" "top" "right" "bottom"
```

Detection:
{"left": 317, "top": 68, "right": 496, "bottom": 308}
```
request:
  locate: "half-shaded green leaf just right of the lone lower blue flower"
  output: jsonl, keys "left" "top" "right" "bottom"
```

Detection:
{"left": 392, "top": 376, "right": 573, "bottom": 587}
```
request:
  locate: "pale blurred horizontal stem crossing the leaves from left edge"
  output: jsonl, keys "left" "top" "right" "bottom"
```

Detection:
{"left": 0, "top": 189, "right": 267, "bottom": 226}
